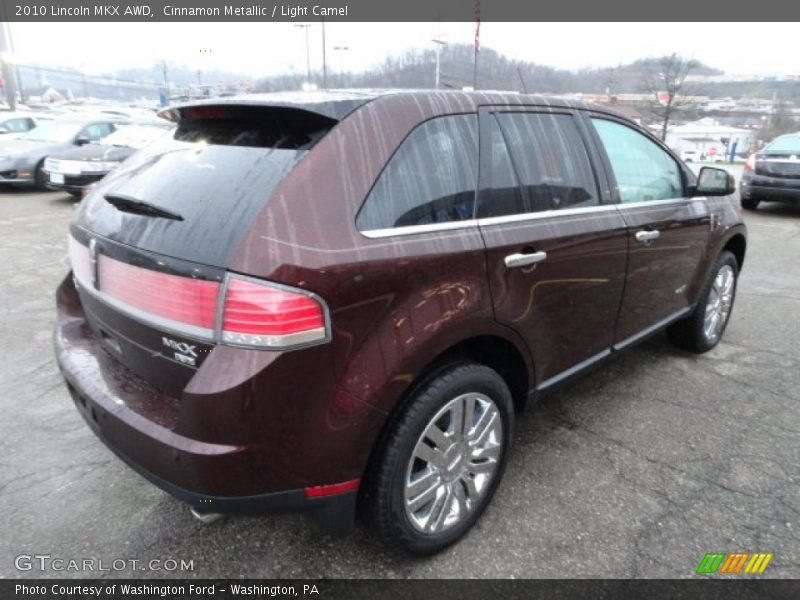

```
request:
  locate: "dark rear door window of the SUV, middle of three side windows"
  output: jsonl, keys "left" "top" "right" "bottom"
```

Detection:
{"left": 479, "top": 113, "right": 599, "bottom": 217}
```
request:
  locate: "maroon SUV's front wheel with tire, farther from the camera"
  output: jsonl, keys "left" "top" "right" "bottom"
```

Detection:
{"left": 667, "top": 250, "right": 739, "bottom": 354}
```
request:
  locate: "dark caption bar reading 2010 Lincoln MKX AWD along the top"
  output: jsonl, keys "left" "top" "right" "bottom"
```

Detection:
{"left": 0, "top": 0, "right": 800, "bottom": 22}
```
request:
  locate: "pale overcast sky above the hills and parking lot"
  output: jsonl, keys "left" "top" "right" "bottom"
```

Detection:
{"left": 10, "top": 23, "right": 800, "bottom": 77}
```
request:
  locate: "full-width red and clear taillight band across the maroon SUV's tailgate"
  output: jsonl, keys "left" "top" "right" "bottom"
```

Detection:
{"left": 69, "top": 236, "right": 330, "bottom": 349}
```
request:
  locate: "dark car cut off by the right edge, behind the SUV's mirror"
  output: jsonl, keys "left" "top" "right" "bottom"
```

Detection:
{"left": 739, "top": 133, "right": 800, "bottom": 210}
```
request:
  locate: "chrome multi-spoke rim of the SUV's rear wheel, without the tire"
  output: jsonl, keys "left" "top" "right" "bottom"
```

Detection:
{"left": 404, "top": 393, "right": 503, "bottom": 533}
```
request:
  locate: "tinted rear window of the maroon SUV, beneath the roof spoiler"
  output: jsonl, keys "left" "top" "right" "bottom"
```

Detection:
{"left": 78, "top": 107, "right": 336, "bottom": 267}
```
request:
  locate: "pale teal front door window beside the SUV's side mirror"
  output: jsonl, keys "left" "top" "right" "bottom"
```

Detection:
{"left": 592, "top": 119, "right": 683, "bottom": 203}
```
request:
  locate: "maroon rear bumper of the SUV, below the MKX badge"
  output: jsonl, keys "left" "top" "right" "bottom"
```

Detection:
{"left": 54, "top": 278, "right": 382, "bottom": 533}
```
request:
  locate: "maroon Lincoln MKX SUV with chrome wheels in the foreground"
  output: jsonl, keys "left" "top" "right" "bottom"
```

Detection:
{"left": 55, "top": 92, "right": 746, "bottom": 554}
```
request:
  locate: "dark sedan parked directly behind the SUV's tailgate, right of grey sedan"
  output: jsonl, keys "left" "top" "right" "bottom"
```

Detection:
{"left": 44, "top": 121, "right": 172, "bottom": 195}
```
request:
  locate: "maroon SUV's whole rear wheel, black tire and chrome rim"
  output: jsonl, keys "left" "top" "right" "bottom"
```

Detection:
{"left": 366, "top": 361, "right": 514, "bottom": 555}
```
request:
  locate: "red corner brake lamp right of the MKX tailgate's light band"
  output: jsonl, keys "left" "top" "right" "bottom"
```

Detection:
{"left": 222, "top": 277, "right": 327, "bottom": 348}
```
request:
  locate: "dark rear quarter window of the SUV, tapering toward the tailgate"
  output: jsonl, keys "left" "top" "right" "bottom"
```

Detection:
{"left": 356, "top": 114, "right": 478, "bottom": 231}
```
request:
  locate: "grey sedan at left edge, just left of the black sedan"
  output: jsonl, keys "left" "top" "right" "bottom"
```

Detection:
{"left": 0, "top": 114, "right": 125, "bottom": 189}
